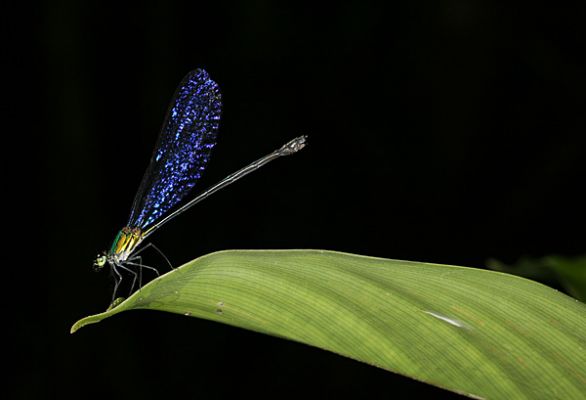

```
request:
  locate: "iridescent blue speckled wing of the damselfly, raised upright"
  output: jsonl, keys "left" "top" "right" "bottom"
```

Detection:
{"left": 128, "top": 69, "right": 222, "bottom": 231}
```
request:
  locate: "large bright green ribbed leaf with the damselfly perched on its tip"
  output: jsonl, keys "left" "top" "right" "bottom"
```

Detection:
{"left": 71, "top": 250, "right": 586, "bottom": 399}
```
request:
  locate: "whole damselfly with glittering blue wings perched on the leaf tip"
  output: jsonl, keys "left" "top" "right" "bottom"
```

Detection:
{"left": 93, "top": 69, "right": 306, "bottom": 301}
